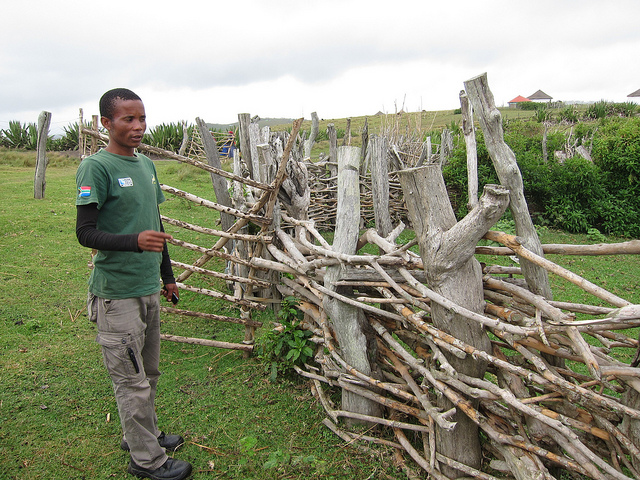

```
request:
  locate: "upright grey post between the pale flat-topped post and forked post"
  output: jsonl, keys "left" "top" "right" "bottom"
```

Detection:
{"left": 369, "top": 135, "right": 393, "bottom": 238}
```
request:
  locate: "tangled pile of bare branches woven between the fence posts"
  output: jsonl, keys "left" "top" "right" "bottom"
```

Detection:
{"left": 83, "top": 102, "right": 640, "bottom": 479}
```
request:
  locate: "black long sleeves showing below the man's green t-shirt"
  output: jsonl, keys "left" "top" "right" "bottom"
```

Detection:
{"left": 76, "top": 203, "right": 176, "bottom": 285}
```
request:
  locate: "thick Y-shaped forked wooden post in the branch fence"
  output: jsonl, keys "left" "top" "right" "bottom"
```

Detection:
{"left": 400, "top": 164, "right": 509, "bottom": 478}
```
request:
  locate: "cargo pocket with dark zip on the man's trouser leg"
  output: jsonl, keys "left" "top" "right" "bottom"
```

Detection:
{"left": 96, "top": 332, "right": 145, "bottom": 385}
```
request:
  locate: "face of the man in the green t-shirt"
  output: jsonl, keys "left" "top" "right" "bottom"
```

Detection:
{"left": 101, "top": 98, "right": 147, "bottom": 156}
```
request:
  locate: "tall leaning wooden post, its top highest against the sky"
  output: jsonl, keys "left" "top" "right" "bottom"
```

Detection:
{"left": 464, "top": 73, "right": 553, "bottom": 300}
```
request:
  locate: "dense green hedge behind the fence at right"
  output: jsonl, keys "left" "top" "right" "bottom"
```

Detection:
{"left": 444, "top": 117, "right": 640, "bottom": 237}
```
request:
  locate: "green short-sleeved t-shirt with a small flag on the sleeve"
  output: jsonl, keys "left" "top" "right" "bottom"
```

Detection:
{"left": 76, "top": 150, "right": 164, "bottom": 299}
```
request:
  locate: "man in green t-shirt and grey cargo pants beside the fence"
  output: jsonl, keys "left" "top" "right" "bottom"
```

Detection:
{"left": 76, "top": 88, "right": 191, "bottom": 480}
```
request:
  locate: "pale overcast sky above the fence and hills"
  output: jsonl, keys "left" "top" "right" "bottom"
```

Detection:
{"left": 0, "top": 0, "right": 640, "bottom": 133}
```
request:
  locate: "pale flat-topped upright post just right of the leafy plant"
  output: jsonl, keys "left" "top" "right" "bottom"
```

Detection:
{"left": 323, "top": 147, "right": 380, "bottom": 424}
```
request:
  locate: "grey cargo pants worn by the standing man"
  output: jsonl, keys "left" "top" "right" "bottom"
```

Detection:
{"left": 87, "top": 293, "right": 168, "bottom": 470}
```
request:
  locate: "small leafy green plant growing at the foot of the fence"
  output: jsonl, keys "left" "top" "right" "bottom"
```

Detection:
{"left": 259, "top": 297, "right": 313, "bottom": 381}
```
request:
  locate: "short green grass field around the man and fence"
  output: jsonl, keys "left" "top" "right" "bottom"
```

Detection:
{"left": 0, "top": 151, "right": 640, "bottom": 480}
